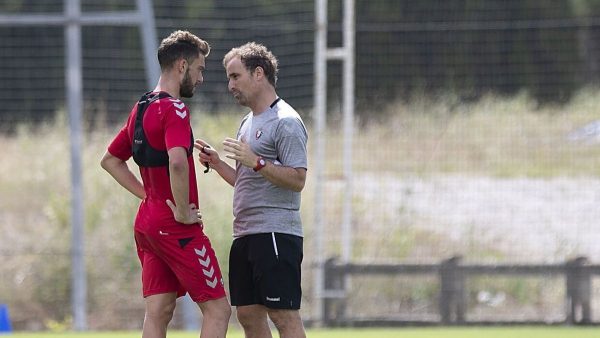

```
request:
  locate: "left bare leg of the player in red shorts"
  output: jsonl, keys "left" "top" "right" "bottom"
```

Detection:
{"left": 142, "top": 292, "right": 177, "bottom": 338}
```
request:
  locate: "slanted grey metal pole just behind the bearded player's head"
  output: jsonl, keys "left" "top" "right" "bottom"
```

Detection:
{"left": 137, "top": 0, "right": 160, "bottom": 90}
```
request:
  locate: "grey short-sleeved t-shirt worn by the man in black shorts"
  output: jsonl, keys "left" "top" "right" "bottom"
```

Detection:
{"left": 233, "top": 100, "right": 308, "bottom": 237}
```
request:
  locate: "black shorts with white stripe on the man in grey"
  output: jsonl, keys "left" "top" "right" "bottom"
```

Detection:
{"left": 229, "top": 232, "right": 303, "bottom": 310}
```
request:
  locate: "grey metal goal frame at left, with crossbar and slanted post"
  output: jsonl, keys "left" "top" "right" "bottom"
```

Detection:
{"left": 0, "top": 0, "right": 160, "bottom": 331}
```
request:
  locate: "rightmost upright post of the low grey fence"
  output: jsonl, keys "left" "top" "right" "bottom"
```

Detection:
{"left": 566, "top": 257, "right": 592, "bottom": 324}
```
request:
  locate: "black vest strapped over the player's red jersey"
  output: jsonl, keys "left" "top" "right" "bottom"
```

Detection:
{"left": 131, "top": 92, "right": 194, "bottom": 168}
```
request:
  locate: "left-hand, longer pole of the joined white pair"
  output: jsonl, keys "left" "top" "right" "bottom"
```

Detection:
{"left": 313, "top": 0, "right": 327, "bottom": 324}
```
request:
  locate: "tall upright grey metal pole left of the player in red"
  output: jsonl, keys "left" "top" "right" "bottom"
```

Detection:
{"left": 65, "top": 0, "right": 87, "bottom": 331}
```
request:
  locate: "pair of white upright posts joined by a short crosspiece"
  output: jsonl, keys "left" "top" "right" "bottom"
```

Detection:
{"left": 313, "top": 0, "right": 355, "bottom": 324}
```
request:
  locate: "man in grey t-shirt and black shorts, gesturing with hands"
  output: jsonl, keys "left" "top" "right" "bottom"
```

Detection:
{"left": 195, "top": 42, "right": 308, "bottom": 338}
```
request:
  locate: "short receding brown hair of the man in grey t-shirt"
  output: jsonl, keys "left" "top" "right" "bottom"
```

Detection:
{"left": 223, "top": 42, "right": 279, "bottom": 87}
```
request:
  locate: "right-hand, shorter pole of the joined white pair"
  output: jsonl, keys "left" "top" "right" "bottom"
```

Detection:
{"left": 342, "top": 0, "right": 355, "bottom": 263}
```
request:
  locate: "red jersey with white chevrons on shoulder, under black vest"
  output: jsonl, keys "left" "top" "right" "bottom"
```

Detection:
{"left": 108, "top": 92, "right": 200, "bottom": 237}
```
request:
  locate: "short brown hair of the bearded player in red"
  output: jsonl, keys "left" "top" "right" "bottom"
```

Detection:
{"left": 158, "top": 30, "right": 210, "bottom": 70}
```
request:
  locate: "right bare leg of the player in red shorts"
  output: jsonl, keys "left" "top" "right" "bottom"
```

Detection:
{"left": 197, "top": 297, "right": 231, "bottom": 338}
